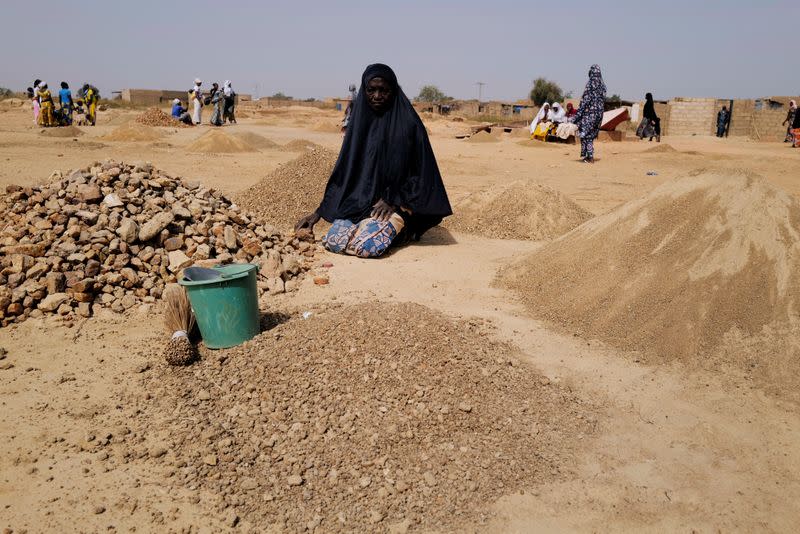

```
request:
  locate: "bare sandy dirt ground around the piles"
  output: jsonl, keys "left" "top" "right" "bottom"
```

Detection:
{"left": 0, "top": 102, "right": 800, "bottom": 533}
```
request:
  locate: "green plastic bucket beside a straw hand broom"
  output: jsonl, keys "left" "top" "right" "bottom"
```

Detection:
{"left": 178, "top": 263, "right": 260, "bottom": 349}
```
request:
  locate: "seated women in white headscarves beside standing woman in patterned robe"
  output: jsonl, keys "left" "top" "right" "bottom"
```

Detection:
{"left": 530, "top": 65, "right": 606, "bottom": 163}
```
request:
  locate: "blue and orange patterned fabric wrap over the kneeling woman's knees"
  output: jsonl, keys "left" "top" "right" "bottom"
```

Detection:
{"left": 323, "top": 213, "right": 403, "bottom": 258}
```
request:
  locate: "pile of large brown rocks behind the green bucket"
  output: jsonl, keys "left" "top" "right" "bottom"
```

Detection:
{"left": 0, "top": 161, "right": 315, "bottom": 326}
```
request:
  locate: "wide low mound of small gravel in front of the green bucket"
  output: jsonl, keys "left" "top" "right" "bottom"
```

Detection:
{"left": 122, "top": 303, "right": 596, "bottom": 532}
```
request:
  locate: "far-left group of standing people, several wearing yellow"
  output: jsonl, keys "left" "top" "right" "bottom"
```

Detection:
{"left": 27, "top": 79, "right": 100, "bottom": 127}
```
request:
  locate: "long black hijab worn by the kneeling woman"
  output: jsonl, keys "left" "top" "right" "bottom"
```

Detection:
{"left": 318, "top": 63, "right": 452, "bottom": 239}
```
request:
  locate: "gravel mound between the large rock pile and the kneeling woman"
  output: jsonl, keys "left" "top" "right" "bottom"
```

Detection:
{"left": 234, "top": 148, "right": 338, "bottom": 228}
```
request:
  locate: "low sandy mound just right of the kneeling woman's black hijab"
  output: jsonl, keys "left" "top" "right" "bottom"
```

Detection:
{"left": 444, "top": 181, "right": 592, "bottom": 241}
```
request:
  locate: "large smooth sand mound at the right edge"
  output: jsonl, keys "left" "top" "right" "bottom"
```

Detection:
{"left": 501, "top": 171, "right": 800, "bottom": 372}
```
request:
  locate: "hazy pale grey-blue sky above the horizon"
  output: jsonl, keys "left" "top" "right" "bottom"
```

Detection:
{"left": 0, "top": 0, "right": 800, "bottom": 100}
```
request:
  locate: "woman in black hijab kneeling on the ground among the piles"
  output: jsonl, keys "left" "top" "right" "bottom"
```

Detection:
{"left": 295, "top": 63, "right": 452, "bottom": 258}
